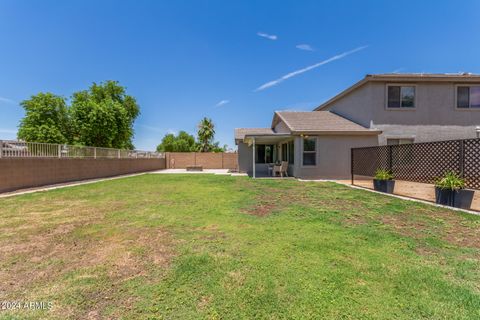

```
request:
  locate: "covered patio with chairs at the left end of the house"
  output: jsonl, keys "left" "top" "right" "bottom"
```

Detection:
{"left": 244, "top": 133, "right": 295, "bottom": 178}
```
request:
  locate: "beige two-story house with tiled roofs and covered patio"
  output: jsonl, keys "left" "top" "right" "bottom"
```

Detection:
{"left": 235, "top": 73, "right": 480, "bottom": 179}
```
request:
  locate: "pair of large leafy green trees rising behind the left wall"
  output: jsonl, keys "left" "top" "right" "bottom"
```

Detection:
{"left": 18, "top": 81, "right": 140, "bottom": 149}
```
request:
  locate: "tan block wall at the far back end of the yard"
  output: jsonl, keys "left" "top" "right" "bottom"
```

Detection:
{"left": 166, "top": 152, "right": 238, "bottom": 170}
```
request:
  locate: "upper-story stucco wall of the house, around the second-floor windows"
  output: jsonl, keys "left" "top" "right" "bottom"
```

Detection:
{"left": 324, "top": 82, "right": 480, "bottom": 144}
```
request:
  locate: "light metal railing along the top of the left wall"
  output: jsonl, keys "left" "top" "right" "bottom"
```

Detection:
{"left": 0, "top": 140, "right": 165, "bottom": 159}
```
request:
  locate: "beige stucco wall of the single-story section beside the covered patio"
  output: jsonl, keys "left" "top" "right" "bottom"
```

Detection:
{"left": 294, "top": 135, "right": 378, "bottom": 179}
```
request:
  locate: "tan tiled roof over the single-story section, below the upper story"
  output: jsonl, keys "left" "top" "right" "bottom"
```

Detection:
{"left": 276, "top": 111, "right": 378, "bottom": 133}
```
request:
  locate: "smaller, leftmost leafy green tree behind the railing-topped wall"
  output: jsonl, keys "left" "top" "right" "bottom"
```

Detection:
{"left": 18, "top": 93, "right": 71, "bottom": 143}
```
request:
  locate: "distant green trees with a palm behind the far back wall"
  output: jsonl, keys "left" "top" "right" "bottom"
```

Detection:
{"left": 157, "top": 118, "right": 227, "bottom": 152}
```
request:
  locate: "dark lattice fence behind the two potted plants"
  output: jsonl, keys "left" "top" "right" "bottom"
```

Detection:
{"left": 351, "top": 139, "right": 480, "bottom": 189}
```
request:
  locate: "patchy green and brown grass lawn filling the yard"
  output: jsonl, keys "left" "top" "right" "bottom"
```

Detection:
{"left": 0, "top": 174, "right": 480, "bottom": 319}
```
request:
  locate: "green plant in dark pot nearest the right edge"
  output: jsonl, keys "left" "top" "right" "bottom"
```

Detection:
{"left": 435, "top": 171, "right": 473, "bottom": 209}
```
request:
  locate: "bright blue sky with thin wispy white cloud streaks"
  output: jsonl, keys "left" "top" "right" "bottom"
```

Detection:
{"left": 0, "top": 0, "right": 480, "bottom": 149}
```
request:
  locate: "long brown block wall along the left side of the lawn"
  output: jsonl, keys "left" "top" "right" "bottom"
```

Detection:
{"left": 0, "top": 158, "right": 165, "bottom": 192}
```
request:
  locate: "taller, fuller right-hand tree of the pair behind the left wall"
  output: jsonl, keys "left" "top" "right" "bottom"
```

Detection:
{"left": 70, "top": 81, "right": 140, "bottom": 149}
